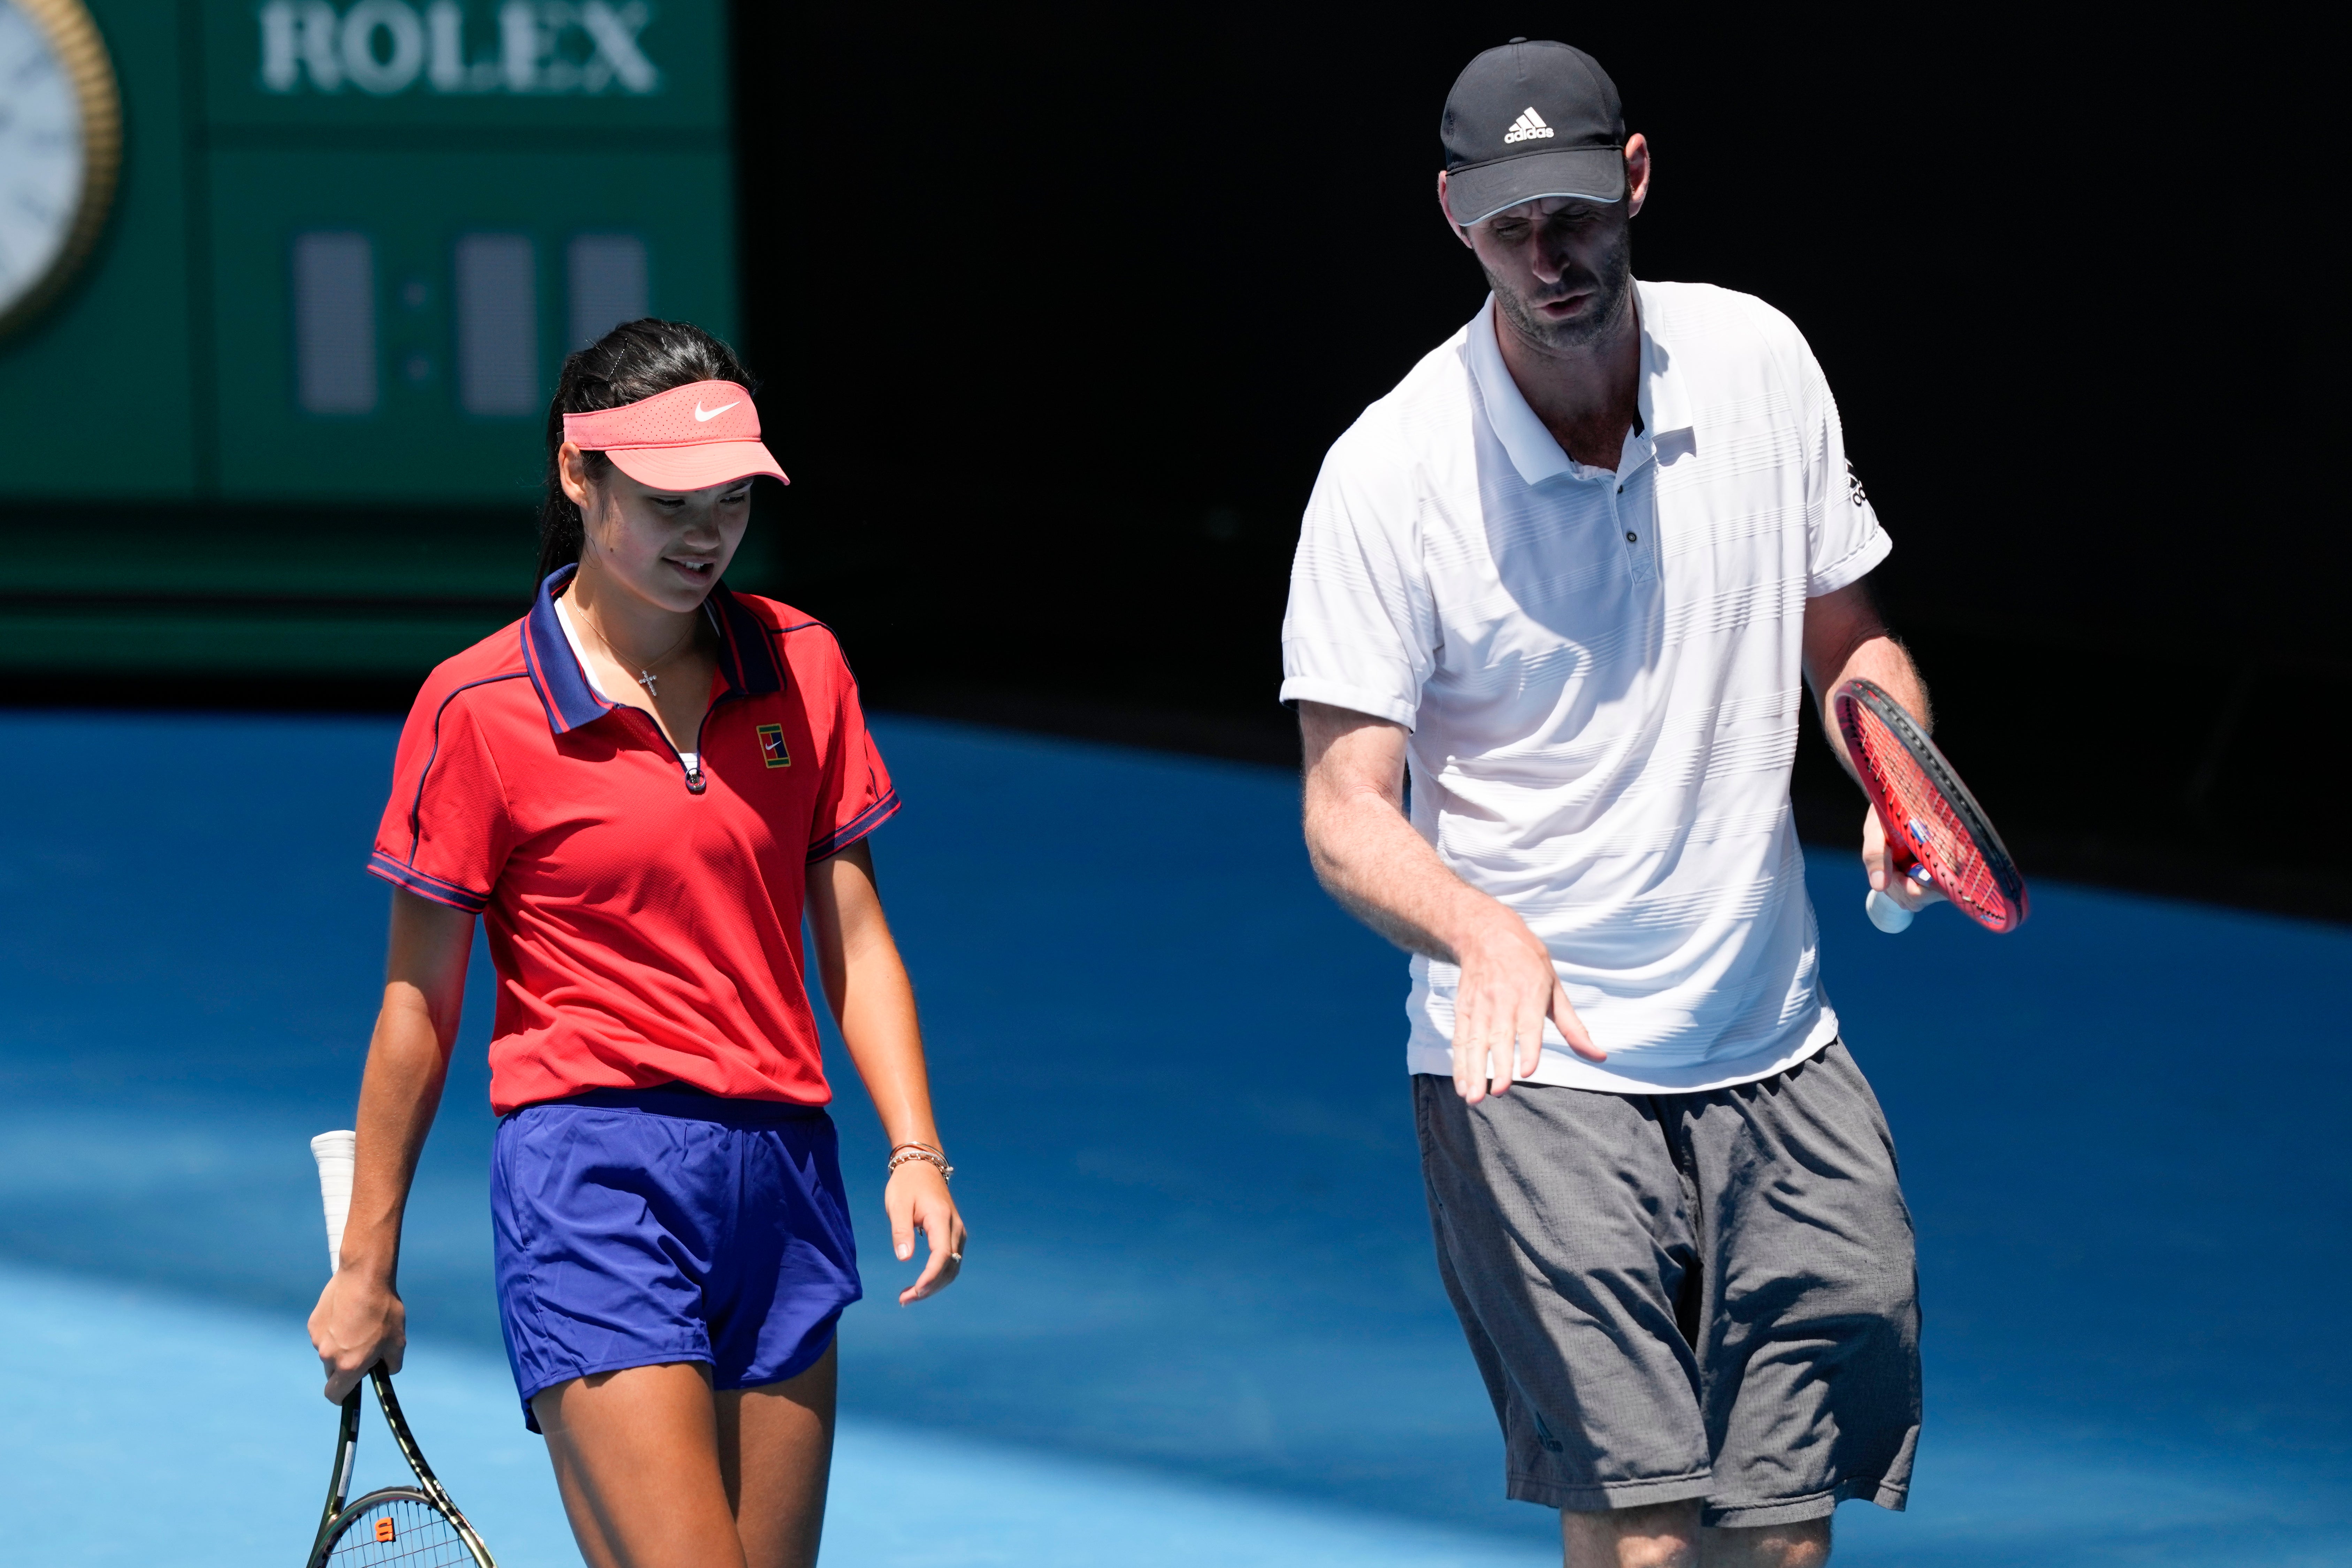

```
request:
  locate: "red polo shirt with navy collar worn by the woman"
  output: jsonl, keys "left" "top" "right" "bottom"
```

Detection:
{"left": 367, "top": 569, "right": 898, "bottom": 1114}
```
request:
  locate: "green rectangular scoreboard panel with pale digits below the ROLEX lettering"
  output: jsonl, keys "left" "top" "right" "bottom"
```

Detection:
{"left": 207, "top": 148, "right": 734, "bottom": 501}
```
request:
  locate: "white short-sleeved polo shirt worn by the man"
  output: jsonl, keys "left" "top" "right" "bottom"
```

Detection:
{"left": 1282, "top": 282, "right": 1891, "bottom": 1093}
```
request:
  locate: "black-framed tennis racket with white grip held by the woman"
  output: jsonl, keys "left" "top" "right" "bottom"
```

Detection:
{"left": 306, "top": 1133, "right": 499, "bottom": 1568}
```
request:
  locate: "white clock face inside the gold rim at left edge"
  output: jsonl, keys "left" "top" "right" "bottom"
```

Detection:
{"left": 0, "top": 0, "right": 87, "bottom": 315}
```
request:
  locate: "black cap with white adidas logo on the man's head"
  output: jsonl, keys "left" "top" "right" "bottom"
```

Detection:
{"left": 1437, "top": 38, "right": 1625, "bottom": 228}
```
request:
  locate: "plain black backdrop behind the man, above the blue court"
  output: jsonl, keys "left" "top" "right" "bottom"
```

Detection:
{"left": 736, "top": 2, "right": 2347, "bottom": 912}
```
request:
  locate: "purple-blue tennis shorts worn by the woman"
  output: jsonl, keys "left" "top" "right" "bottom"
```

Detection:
{"left": 489, "top": 1084, "right": 863, "bottom": 1432}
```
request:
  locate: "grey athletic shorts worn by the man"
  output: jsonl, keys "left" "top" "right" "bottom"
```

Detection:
{"left": 1414, "top": 1042, "right": 1919, "bottom": 1528}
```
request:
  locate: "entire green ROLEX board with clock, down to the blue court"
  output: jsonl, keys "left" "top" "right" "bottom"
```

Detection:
{"left": 0, "top": 0, "right": 736, "bottom": 675}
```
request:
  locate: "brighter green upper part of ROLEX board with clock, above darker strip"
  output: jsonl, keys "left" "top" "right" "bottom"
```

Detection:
{"left": 0, "top": 0, "right": 736, "bottom": 503}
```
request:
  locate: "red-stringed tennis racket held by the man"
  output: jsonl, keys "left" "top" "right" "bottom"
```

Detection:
{"left": 1830, "top": 677, "right": 2025, "bottom": 933}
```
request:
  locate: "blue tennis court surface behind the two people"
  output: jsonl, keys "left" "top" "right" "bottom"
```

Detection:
{"left": 0, "top": 715, "right": 2352, "bottom": 1568}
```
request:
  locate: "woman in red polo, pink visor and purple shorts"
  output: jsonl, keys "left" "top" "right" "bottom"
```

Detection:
{"left": 311, "top": 320, "right": 964, "bottom": 1568}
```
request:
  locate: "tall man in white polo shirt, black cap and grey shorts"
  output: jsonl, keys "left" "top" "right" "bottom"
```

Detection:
{"left": 1282, "top": 40, "right": 1926, "bottom": 1568}
